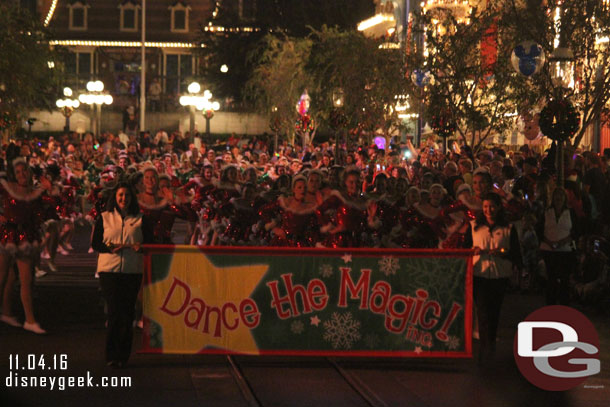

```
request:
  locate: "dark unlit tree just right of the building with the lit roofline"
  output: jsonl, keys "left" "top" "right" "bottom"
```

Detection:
{"left": 195, "top": 0, "right": 374, "bottom": 109}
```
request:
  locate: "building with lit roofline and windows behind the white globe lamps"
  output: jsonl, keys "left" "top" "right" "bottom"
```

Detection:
{"left": 29, "top": 0, "right": 267, "bottom": 133}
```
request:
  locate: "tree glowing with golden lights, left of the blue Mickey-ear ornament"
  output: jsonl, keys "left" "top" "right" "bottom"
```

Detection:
{"left": 406, "top": 3, "right": 522, "bottom": 152}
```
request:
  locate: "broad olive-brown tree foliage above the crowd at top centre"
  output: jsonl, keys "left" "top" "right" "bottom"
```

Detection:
{"left": 248, "top": 27, "right": 406, "bottom": 147}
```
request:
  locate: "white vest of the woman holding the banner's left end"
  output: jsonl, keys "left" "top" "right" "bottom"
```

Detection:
{"left": 92, "top": 209, "right": 144, "bottom": 274}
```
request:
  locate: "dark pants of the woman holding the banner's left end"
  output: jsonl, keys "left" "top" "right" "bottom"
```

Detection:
{"left": 99, "top": 273, "right": 142, "bottom": 362}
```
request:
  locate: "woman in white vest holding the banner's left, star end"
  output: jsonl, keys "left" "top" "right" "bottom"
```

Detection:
{"left": 91, "top": 182, "right": 152, "bottom": 368}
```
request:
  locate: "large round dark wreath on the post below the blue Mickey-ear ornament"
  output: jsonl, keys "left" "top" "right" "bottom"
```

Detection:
{"left": 538, "top": 99, "right": 580, "bottom": 141}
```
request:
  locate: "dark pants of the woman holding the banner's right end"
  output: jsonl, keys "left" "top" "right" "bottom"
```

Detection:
{"left": 473, "top": 277, "right": 508, "bottom": 351}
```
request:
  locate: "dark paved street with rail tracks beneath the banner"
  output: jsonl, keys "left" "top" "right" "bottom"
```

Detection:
{"left": 0, "top": 225, "right": 610, "bottom": 407}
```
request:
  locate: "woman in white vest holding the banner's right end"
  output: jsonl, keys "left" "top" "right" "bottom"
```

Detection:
{"left": 466, "top": 192, "right": 522, "bottom": 361}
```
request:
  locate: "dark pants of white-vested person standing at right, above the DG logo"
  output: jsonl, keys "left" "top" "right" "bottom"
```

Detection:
{"left": 541, "top": 251, "right": 576, "bottom": 305}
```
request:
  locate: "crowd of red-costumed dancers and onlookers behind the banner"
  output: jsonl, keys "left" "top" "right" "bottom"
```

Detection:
{"left": 0, "top": 131, "right": 608, "bottom": 331}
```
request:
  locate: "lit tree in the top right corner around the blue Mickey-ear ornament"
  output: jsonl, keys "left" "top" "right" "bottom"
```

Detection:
{"left": 503, "top": 0, "right": 610, "bottom": 147}
